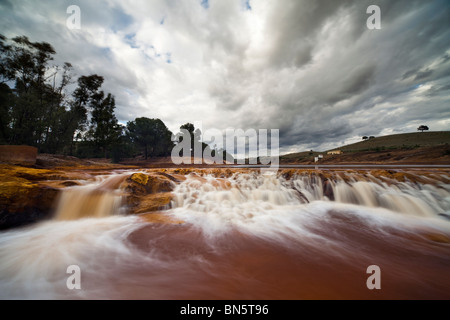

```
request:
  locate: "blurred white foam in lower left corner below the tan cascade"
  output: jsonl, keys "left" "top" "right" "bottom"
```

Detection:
{"left": 0, "top": 216, "right": 141, "bottom": 299}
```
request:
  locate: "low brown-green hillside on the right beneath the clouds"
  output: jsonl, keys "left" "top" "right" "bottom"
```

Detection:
{"left": 280, "top": 131, "right": 450, "bottom": 164}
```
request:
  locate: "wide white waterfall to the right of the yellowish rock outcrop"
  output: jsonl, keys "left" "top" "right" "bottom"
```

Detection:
{"left": 173, "top": 173, "right": 450, "bottom": 217}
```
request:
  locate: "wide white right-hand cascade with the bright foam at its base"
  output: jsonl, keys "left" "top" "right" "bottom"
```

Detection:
{"left": 170, "top": 174, "right": 450, "bottom": 238}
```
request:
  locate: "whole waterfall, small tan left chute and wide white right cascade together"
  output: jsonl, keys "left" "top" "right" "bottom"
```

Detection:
{"left": 49, "top": 172, "right": 450, "bottom": 220}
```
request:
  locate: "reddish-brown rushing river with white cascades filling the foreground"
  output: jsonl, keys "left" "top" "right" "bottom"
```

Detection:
{"left": 0, "top": 172, "right": 450, "bottom": 299}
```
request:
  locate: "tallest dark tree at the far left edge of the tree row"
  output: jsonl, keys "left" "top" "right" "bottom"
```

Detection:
{"left": 0, "top": 35, "right": 78, "bottom": 153}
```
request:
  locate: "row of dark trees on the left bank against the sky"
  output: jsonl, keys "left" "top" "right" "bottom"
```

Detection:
{"left": 0, "top": 35, "right": 222, "bottom": 160}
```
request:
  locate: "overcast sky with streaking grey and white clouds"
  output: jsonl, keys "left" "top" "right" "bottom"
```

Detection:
{"left": 0, "top": 0, "right": 450, "bottom": 153}
